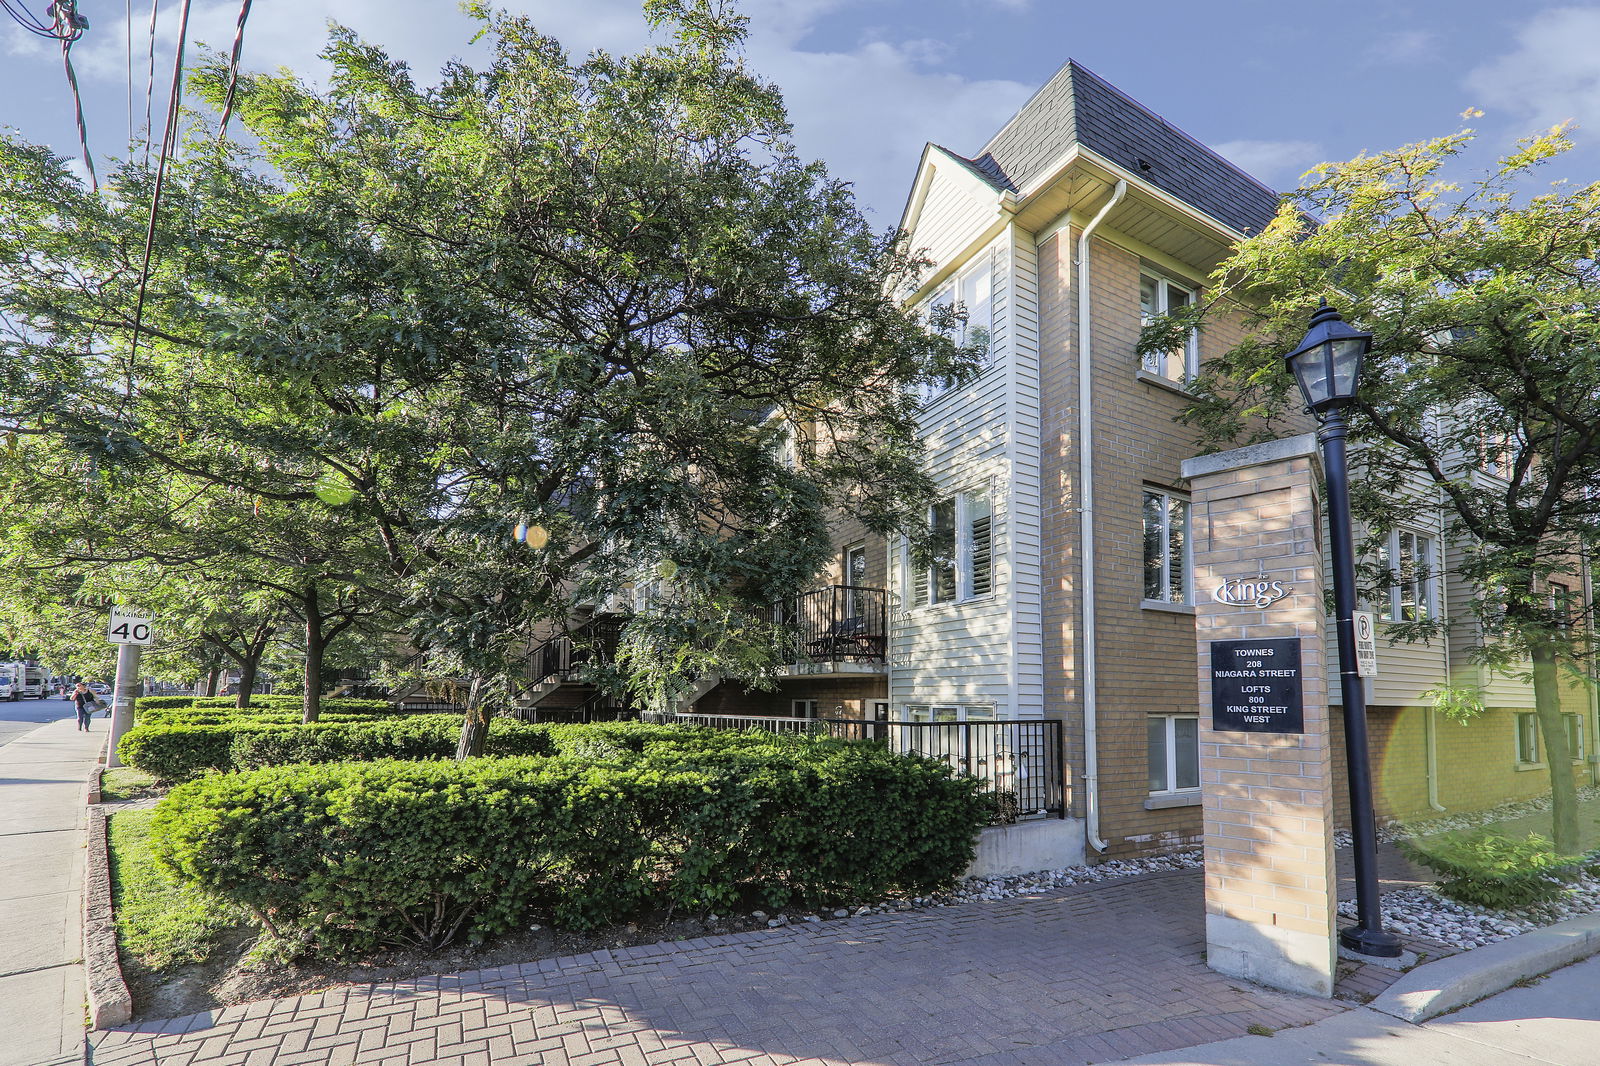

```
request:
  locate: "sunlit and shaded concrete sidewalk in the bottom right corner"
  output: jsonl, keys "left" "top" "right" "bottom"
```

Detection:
{"left": 1123, "top": 956, "right": 1600, "bottom": 1066}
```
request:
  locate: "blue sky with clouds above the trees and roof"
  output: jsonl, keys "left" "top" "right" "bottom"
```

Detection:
{"left": 0, "top": 0, "right": 1600, "bottom": 226}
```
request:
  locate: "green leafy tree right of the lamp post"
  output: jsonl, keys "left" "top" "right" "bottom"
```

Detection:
{"left": 1164, "top": 118, "right": 1600, "bottom": 853}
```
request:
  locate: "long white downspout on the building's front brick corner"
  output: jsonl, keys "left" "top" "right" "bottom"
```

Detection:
{"left": 1077, "top": 179, "right": 1128, "bottom": 852}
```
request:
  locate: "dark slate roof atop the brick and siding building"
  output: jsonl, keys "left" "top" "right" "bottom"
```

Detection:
{"left": 970, "top": 59, "right": 1278, "bottom": 232}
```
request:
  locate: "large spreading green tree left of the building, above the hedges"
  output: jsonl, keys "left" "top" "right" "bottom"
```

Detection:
{"left": 0, "top": 0, "right": 974, "bottom": 754}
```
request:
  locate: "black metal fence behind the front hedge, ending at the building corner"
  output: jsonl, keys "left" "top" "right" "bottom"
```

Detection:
{"left": 642, "top": 714, "right": 1067, "bottom": 821}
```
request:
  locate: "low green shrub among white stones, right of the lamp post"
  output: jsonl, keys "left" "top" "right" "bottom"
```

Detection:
{"left": 1400, "top": 832, "right": 1579, "bottom": 911}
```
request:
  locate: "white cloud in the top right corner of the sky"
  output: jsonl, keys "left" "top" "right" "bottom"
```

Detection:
{"left": 1464, "top": 8, "right": 1600, "bottom": 126}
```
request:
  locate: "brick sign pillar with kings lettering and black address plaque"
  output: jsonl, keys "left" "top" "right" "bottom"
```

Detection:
{"left": 1184, "top": 434, "right": 1338, "bottom": 996}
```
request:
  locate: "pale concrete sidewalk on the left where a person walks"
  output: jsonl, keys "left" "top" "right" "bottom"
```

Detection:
{"left": 0, "top": 704, "right": 109, "bottom": 1066}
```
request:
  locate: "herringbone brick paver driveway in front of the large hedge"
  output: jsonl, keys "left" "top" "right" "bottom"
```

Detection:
{"left": 90, "top": 871, "right": 1341, "bottom": 1066}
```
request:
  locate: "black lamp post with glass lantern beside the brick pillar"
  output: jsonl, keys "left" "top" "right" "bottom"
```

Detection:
{"left": 1283, "top": 301, "right": 1400, "bottom": 959}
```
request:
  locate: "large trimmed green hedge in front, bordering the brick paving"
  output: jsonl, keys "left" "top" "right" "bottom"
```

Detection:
{"left": 152, "top": 735, "right": 989, "bottom": 957}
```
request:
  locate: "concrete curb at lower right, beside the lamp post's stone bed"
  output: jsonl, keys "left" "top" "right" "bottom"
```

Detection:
{"left": 1368, "top": 914, "right": 1600, "bottom": 1023}
